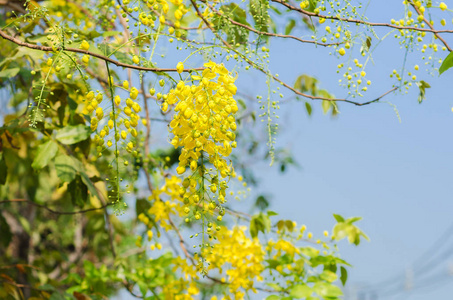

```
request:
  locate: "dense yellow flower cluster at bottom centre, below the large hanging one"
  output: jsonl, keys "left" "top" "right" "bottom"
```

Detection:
{"left": 205, "top": 226, "right": 265, "bottom": 299}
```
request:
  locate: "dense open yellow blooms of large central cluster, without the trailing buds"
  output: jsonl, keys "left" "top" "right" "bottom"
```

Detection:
{"left": 162, "top": 62, "right": 238, "bottom": 178}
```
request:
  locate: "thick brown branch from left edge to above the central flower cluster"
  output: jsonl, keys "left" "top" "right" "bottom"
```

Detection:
{"left": 0, "top": 29, "right": 205, "bottom": 72}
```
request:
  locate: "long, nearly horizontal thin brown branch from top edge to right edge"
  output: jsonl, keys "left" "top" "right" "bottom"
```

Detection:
{"left": 271, "top": 0, "right": 453, "bottom": 33}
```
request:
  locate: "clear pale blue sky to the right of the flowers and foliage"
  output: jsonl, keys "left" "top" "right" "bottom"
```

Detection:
{"left": 244, "top": 1, "right": 453, "bottom": 300}
